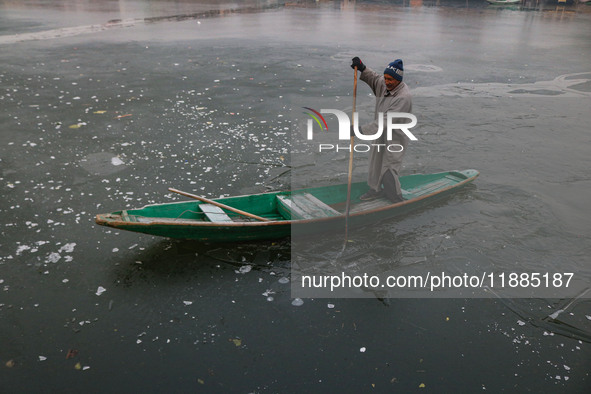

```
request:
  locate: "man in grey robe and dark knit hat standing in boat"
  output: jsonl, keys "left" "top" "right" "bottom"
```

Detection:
{"left": 351, "top": 57, "right": 412, "bottom": 203}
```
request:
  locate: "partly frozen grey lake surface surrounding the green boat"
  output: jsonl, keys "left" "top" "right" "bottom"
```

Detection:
{"left": 0, "top": 0, "right": 591, "bottom": 392}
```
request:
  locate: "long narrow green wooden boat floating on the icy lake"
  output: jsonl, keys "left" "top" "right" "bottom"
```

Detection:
{"left": 96, "top": 170, "right": 478, "bottom": 242}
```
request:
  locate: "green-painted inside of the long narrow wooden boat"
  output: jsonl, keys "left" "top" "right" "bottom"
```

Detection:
{"left": 117, "top": 170, "right": 478, "bottom": 221}
